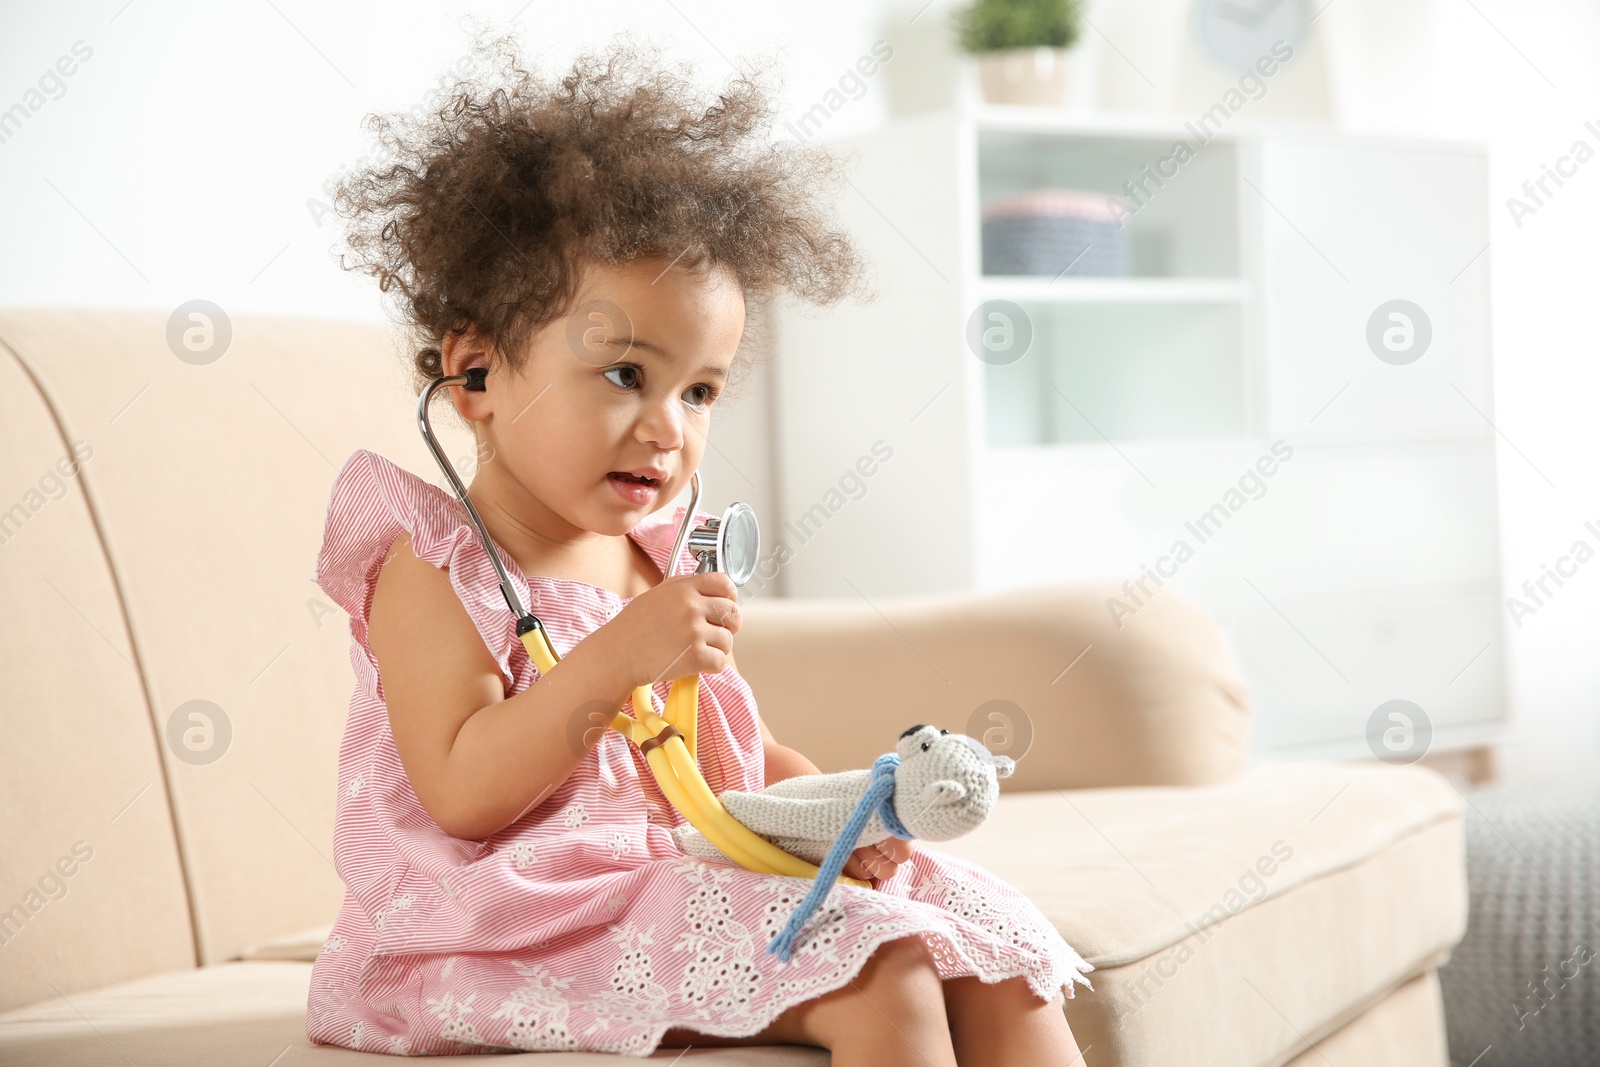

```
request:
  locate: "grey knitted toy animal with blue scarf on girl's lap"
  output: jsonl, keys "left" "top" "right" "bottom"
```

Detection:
{"left": 672, "top": 723, "right": 1016, "bottom": 963}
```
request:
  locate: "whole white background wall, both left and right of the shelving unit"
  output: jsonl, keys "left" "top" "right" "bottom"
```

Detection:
{"left": 0, "top": 0, "right": 1600, "bottom": 790}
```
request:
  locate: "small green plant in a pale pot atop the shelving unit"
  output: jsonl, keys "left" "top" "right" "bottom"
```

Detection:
{"left": 955, "top": 0, "right": 1078, "bottom": 107}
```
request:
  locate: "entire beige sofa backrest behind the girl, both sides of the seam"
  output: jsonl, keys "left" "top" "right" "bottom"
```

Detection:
{"left": 0, "top": 309, "right": 466, "bottom": 1008}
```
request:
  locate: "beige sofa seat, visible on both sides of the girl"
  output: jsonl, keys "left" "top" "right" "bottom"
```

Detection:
{"left": 0, "top": 763, "right": 1466, "bottom": 1067}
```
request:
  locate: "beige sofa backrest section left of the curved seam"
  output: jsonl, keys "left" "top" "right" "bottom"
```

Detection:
{"left": 0, "top": 315, "right": 194, "bottom": 1009}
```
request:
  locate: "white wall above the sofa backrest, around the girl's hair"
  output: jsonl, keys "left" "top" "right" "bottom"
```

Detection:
{"left": 0, "top": 0, "right": 902, "bottom": 559}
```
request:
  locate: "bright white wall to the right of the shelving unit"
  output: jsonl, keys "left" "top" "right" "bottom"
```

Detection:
{"left": 1326, "top": 0, "right": 1600, "bottom": 792}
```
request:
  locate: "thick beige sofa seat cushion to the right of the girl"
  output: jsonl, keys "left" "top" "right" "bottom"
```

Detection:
{"left": 938, "top": 763, "right": 1466, "bottom": 1067}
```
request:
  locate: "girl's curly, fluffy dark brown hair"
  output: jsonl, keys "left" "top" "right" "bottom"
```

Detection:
{"left": 334, "top": 32, "right": 866, "bottom": 404}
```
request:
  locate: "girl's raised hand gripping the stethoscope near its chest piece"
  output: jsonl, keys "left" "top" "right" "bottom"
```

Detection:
{"left": 595, "top": 571, "right": 741, "bottom": 688}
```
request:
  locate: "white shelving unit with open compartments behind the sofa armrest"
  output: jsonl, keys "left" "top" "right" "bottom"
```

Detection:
{"left": 771, "top": 109, "right": 1506, "bottom": 755}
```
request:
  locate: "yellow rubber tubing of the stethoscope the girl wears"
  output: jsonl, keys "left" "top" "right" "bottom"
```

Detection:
{"left": 522, "top": 625, "right": 872, "bottom": 889}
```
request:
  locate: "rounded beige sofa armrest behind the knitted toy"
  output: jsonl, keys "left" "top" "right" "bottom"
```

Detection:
{"left": 734, "top": 582, "right": 1250, "bottom": 792}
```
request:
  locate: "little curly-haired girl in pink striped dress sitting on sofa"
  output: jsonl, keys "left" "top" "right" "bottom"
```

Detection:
{"left": 307, "top": 29, "right": 1093, "bottom": 1067}
